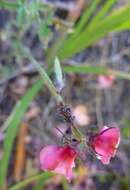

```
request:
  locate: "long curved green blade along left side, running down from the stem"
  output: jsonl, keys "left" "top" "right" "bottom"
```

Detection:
{"left": 0, "top": 81, "right": 43, "bottom": 189}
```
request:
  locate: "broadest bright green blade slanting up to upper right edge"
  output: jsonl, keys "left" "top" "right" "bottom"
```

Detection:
{"left": 59, "top": 5, "right": 130, "bottom": 59}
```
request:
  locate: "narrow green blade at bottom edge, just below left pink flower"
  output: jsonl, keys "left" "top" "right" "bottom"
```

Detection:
{"left": 9, "top": 172, "right": 54, "bottom": 190}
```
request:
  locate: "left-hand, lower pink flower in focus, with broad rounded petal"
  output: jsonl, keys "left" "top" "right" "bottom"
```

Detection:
{"left": 40, "top": 145, "right": 77, "bottom": 181}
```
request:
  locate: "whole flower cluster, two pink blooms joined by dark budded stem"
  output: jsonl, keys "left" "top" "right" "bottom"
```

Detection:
{"left": 40, "top": 105, "right": 120, "bottom": 181}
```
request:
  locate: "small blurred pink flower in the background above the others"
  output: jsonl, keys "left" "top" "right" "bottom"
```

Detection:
{"left": 98, "top": 75, "right": 115, "bottom": 88}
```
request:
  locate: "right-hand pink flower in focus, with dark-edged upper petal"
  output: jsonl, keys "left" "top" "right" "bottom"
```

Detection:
{"left": 90, "top": 126, "right": 120, "bottom": 164}
